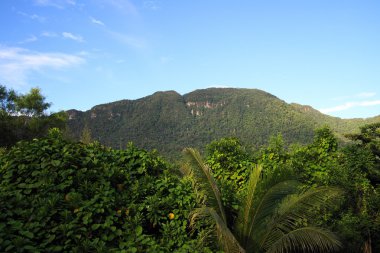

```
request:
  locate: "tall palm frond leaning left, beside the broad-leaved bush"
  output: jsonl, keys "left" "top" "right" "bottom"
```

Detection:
{"left": 183, "top": 148, "right": 227, "bottom": 223}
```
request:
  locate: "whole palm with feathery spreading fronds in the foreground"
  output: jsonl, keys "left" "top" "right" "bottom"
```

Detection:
{"left": 182, "top": 148, "right": 341, "bottom": 252}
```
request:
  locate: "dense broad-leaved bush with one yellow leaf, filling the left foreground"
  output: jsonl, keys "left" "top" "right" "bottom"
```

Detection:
{"left": 0, "top": 134, "right": 208, "bottom": 252}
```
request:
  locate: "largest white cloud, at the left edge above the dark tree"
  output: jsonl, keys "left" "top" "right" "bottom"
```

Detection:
{"left": 0, "top": 45, "right": 86, "bottom": 87}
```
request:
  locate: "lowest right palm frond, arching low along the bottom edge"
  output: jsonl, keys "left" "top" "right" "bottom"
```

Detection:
{"left": 266, "top": 227, "right": 342, "bottom": 253}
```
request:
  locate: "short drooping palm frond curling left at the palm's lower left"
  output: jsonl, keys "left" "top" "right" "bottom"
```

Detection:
{"left": 190, "top": 206, "right": 245, "bottom": 253}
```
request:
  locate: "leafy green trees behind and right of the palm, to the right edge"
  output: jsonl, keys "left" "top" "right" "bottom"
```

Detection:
{"left": 256, "top": 124, "right": 380, "bottom": 252}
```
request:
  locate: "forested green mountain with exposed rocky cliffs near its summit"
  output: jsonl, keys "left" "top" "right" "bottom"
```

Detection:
{"left": 67, "top": 88, "right": 380, "bottom": 157}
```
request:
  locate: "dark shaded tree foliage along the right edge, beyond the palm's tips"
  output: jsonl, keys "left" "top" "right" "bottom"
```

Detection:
{"left": 331, "top": 124, "right": 380, "bottom": 252}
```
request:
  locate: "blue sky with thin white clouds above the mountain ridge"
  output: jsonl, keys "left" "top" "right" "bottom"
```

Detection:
{"left": 0, "top": 0, "right": 380, "bottom": 118}
